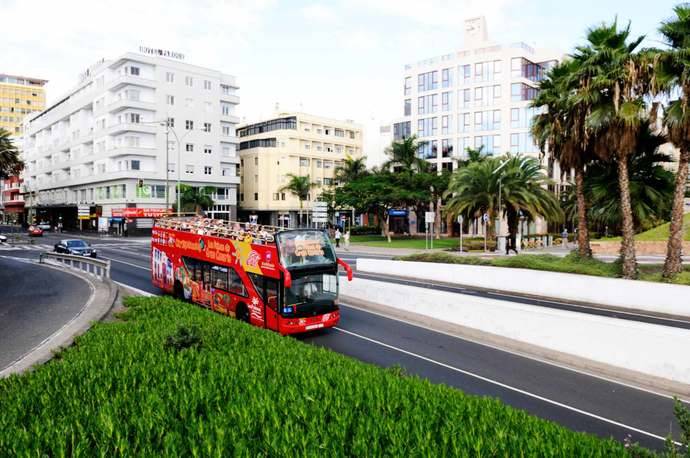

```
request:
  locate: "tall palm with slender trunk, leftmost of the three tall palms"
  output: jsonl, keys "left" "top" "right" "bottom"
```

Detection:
{"left": 532, "top": 58, "right": 593, "bottom": 257}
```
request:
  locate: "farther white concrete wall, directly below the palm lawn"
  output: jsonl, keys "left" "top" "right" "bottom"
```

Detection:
{"left": 357, "top": 258, "right": 690, "bottom": 318}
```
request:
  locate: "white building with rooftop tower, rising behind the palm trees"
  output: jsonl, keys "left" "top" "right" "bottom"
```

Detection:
{"left": 393, "top": 17, "right": 563, "bottom": 174}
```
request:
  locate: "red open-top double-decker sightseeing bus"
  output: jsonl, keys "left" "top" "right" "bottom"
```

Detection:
{"left": 151, "top": 217, "right": 352, "bottom": 334}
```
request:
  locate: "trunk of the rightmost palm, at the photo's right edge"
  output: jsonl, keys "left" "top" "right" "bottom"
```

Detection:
{"left": 663, "top": 151, "right": 690, "bottom": 280}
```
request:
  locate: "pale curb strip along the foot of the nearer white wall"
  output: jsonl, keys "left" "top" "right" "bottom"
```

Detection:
{"left": 339, "top": 294, "right": 690, "bottom": 400}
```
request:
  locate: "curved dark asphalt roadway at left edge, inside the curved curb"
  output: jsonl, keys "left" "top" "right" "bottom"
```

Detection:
{"left": 0, "top": 253, "right": 91, "bottom": 370}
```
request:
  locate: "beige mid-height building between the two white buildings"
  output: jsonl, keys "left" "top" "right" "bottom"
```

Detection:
{"left": 237, "top": 113, "right": 362, "bottom": 227}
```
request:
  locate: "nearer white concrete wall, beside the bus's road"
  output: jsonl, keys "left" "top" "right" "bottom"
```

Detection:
{"left": 340, "top": 278, "right": 690, "bottom": 396}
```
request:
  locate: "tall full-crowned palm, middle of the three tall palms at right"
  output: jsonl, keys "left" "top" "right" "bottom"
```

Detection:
{"left": 580, "top": 21, "right": 650, "bottom": 278}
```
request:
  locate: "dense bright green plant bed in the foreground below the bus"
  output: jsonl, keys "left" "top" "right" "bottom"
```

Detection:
{"left": 0, "top": 297, "right": 649, "bottom": 457}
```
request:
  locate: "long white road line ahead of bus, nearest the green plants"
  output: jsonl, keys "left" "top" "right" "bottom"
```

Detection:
{"left": 333, "top": 326, "right": 681, "bottom": 445}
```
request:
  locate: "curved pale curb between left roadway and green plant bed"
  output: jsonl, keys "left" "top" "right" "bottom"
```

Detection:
{"left": 0, "top": 263, "right": 119, "bottom": 378}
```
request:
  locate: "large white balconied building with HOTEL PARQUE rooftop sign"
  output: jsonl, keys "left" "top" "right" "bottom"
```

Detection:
{"left": 22, "top": 48, "right": 240, "bottom": 233}
